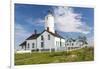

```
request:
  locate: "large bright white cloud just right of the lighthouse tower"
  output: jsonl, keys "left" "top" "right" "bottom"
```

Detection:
{"left": 53, "top": 7, "right": 91, "bottom": 34}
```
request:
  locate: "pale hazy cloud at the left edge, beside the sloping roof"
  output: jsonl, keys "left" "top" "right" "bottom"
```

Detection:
{"left": 15, "top": 23, "right": 31, "bottom": 46}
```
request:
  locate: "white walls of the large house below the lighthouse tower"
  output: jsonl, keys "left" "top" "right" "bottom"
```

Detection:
{"left": 23, "top": 31, "right": 65, "bottom": 50}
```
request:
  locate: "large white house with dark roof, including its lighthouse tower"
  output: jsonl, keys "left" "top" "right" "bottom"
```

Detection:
{"left": 20, "top": 12, "right": 66, "bottom": 52}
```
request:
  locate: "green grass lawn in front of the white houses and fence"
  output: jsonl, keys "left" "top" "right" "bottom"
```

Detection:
{"left": 15, "top": 47, "right": 94, "bottom": 65}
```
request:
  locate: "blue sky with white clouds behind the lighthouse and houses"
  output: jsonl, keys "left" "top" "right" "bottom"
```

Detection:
{"left": 14, "top": 4, "right": 94, "bottom": 46}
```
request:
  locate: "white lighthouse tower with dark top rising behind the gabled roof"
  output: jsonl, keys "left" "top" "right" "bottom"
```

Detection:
{"left": 45, "top": 11, "right": 55, "bottom": 33}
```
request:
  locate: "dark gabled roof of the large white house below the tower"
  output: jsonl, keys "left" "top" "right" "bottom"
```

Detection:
{"left": 20, "top": 30, "right": 64, "bottom": 46}
